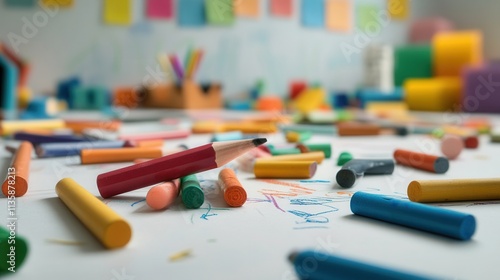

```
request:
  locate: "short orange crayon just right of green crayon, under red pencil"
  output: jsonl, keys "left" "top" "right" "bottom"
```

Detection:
{"left": 218, "top": 168, "right": 247, "bottom": 207}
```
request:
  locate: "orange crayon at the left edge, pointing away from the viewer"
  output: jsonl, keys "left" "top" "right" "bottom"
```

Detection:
{"left": 2, "top": 141, "right": 33, "bottom": 197}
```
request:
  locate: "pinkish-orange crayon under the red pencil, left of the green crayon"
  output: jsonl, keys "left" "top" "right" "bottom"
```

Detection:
{"left": 146, "top": 179, "right": 179, "bottom": 210}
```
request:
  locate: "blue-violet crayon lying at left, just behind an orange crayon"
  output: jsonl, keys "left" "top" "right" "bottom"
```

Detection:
{"left": 35, "top": 141, "right": 125, "bottom": 158}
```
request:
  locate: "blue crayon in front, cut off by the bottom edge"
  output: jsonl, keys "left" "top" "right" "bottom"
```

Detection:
{"left": 289, "top": 250, "right": 433, "bottom": 280}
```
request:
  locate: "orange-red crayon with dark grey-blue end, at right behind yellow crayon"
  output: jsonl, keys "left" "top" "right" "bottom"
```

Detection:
{"left": 394, "top": 149, "right": 450, "bottom": 174}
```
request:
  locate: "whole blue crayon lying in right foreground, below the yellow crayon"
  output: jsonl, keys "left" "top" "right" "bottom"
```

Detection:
{"left": 351, "top": 192, "right": 476, "bottom": 240}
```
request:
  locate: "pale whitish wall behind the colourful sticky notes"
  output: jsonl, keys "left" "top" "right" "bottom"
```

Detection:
{"left": 0, "top": 0, "right": 436, "bottom": 98}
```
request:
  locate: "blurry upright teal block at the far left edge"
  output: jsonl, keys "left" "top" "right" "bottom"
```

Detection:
{"left": 0, "top": 54, "right": 19, "bottom": 120}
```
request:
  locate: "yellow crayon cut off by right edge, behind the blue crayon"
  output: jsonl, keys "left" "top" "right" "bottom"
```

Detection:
{"left": 407, "top": 178, "right": 500, "bottom": 202}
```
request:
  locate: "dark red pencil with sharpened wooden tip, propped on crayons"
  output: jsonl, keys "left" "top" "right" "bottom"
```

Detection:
{"left": 97, "top": 138, "right": 267, "bottom": 198}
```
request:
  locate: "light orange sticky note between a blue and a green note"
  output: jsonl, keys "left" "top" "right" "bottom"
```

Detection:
{"left": 326, "top": 0, "right": 352, "bottom": 32}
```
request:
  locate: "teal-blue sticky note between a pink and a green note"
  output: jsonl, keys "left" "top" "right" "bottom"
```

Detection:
{"left": 177, "top": 0, "right": 206, "bottom": 26}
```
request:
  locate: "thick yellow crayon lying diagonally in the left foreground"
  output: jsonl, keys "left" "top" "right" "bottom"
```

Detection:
{"left": 56, "top": 178, "right": 132, "bottom": 249}
